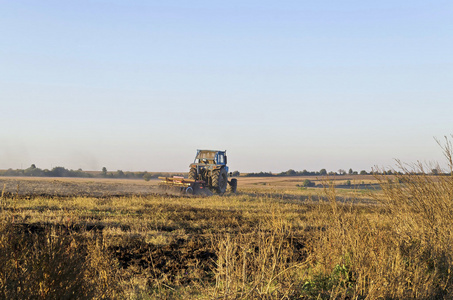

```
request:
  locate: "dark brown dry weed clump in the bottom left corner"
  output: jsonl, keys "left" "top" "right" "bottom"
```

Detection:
{"left": 0, "top": 219, "right": 119, "bottom": 299}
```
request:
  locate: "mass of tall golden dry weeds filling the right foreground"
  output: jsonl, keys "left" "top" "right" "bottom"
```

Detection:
{"left": 302, "top": 140, "right": 453, "bottom": 299}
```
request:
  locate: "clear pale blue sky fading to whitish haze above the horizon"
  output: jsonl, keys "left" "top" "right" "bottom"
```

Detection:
{"left": 0, "top": 0, "right": 453, "bottom": 172}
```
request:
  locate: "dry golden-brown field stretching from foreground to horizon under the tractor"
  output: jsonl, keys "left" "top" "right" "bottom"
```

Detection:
{"left": 0, "top": 172, "right": 453, "bottom": 299}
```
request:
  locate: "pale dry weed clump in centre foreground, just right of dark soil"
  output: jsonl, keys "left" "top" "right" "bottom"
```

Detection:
{"left": 213, "top": 206, "right": 305, "bottom": 299}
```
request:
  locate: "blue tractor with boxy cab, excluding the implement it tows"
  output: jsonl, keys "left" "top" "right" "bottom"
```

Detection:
{"left": 189, "top": 150, "right": 237, "bottom": 194}
